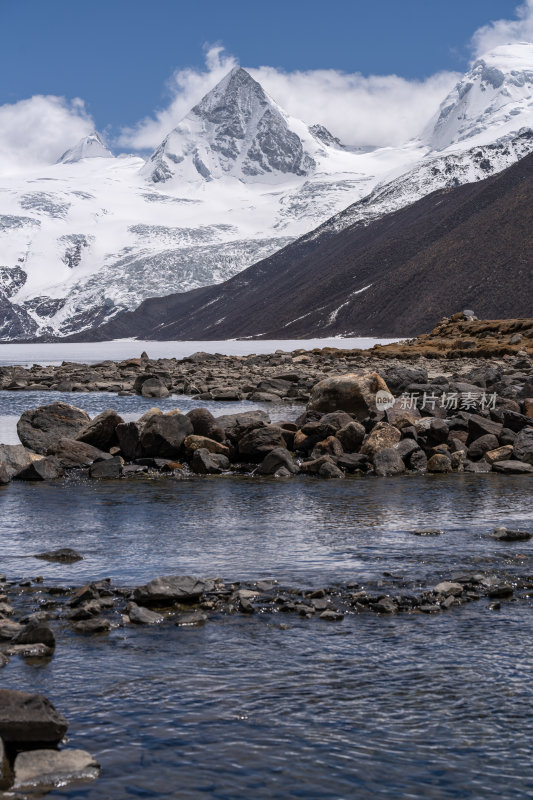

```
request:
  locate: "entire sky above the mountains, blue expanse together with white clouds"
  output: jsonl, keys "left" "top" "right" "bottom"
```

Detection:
{"left": 0, "top": 0, "right": 533, "bottom": 169}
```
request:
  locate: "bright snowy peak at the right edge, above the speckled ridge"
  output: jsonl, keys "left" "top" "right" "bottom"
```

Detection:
{"left": 423, "top": 42, "right": 533, "bottom": 150}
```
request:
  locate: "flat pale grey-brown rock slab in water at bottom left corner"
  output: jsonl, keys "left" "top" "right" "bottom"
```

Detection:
{"left": 13, "top": 750, "right": 100, "bottom": 793}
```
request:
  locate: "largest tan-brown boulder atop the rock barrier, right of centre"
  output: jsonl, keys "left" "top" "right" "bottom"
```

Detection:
{"left": 308, "top": 372, "right": 389, "bottom": 420}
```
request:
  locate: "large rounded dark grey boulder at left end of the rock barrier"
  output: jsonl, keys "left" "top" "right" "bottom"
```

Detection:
{"left": 17, "top": 403, "right": 91, "bottom": 455}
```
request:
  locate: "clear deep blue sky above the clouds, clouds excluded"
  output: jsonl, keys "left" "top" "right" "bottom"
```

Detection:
{"left": 0, "top": 0, "right": 517, "bottom": 127}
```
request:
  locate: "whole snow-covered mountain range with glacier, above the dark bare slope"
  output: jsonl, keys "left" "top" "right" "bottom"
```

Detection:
{"left": 0, "top": 45, "right": 533, "bottom": 340}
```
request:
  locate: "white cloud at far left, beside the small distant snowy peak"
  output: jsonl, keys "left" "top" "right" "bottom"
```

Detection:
{"left": 0, "top": 95, "right": 94, "bottom": 175}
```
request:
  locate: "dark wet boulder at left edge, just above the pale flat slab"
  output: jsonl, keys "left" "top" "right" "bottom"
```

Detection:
{"left": 0, "top": 689, "right": 68, "bottom": 747}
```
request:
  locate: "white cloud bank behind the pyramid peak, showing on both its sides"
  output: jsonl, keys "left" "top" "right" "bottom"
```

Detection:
{"left": 119, "top": 45, "right": 460, "bottom": 150}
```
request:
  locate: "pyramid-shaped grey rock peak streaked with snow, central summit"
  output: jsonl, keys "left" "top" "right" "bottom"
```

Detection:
{"left": 141, "top": 67, "right": 350, "bottom": 183}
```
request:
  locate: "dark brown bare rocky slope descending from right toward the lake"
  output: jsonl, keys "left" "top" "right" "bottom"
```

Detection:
{"left": 66, "top": 150, "right": 533, "bottom": 340}
